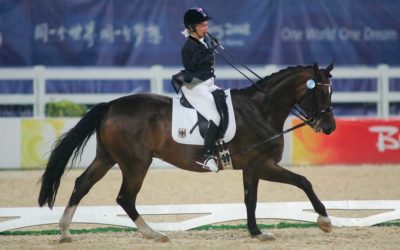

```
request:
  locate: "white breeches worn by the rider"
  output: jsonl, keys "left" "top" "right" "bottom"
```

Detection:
{"left": 182, "top": 77, "right": 221, "bottom": 126}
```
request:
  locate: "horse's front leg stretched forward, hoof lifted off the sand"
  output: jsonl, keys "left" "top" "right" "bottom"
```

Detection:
{"left": 257, "top": 163, "right": 332, "bottom": 233}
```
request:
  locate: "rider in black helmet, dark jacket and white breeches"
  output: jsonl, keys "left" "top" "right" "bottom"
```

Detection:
{"left": 181, "top": 8, "right": 221, "bottom": 172}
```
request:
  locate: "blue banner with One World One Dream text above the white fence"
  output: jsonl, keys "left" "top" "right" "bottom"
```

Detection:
{"left": 0, "top": 0, "right": 400, "bottom": 66}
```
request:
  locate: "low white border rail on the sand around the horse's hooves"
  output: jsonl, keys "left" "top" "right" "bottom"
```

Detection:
{"left": 0, "top": 200, "right": 400, "bottom": 232}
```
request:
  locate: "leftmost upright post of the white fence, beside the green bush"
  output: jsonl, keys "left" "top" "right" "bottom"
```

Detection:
{"left": 33, "top": 66, "right": 46, "bottom": 117}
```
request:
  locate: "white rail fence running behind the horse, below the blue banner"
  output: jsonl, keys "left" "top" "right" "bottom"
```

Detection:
{"left": 0, "top": 65, "right": 400, "bottom": 118}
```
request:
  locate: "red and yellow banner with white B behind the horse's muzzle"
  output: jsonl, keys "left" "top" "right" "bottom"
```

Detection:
{"left": 292, "top": 118, "right": 400, "bottom": 164}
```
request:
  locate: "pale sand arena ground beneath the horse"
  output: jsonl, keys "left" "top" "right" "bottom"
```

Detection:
{"left": 0, "top": 165, "right": 400, "bottom": 249}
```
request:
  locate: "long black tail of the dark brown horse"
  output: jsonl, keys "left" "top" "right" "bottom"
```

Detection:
{"left": 38, "top": 103, "right": 109, "bottom": 208}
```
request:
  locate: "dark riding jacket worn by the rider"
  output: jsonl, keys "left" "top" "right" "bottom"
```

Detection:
{"left": 181, "top": 36, "right": 215, "bottom": 83}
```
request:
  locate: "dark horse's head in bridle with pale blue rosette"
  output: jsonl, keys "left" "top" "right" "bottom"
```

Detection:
{"left": 298, "top": 63, "right": 336, "bottom": 135}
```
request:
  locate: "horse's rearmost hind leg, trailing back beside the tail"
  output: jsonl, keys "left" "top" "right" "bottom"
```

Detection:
{"left": 59, "top": 156, "right": 115, "bottom": 243}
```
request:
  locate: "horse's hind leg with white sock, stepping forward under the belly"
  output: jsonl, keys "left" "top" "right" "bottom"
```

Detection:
{"left": 117, "top": 162, "right": 169, "bottom": 242}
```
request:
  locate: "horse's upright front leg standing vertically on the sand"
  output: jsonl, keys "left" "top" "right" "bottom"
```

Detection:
{"left": 243, "top": 169, "right": 275, "bottom": 241}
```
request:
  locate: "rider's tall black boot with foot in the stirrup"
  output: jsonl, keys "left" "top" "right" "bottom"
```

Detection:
{"left": 203, "top": 120, "right": 218, "bottom": 172}
